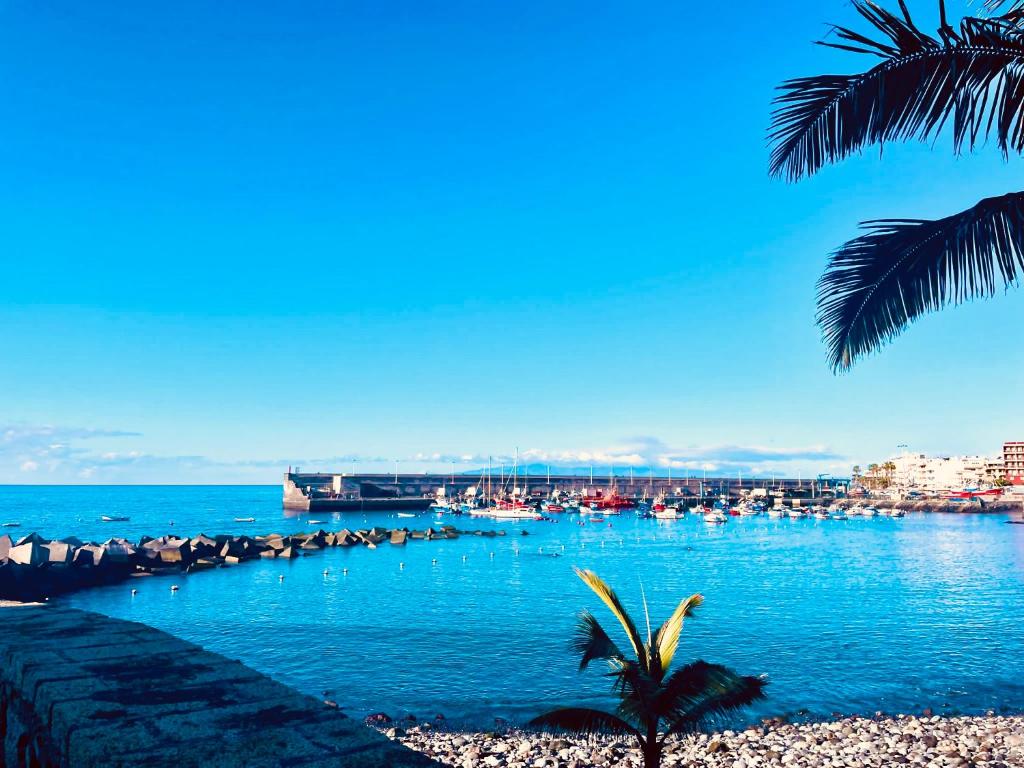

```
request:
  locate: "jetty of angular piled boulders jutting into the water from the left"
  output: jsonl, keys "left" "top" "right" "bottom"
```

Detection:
{"left": 0, "top": 525, "right": 505, "bottom": 602}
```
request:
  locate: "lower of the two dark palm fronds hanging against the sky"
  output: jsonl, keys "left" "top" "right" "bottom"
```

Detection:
{"left": 817, "top": 193, "right": 1024, "bottom": 370}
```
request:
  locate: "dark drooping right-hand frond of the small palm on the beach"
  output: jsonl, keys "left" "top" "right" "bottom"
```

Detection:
{"left": 655, "top": 662, "right": 768, "bottom": 737}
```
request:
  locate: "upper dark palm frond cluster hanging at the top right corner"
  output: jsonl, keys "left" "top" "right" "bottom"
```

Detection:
{"left": 769, "top": 0, "right": 1024, "bottom": 180}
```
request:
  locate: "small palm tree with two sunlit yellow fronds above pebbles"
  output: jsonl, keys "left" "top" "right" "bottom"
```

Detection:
{"left": 530, "top": 568, "right": 767, "bottom": 768}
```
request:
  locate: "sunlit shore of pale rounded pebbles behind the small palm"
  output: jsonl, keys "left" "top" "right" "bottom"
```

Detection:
{"left": 379, "top": 716, "right": 1024, "bottom": 768}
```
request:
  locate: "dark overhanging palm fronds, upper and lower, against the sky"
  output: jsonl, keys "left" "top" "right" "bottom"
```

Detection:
{"left": 769, "top": 0, "right": 1024, "bottom": 371}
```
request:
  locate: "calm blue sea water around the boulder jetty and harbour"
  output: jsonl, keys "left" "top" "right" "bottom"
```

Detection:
{"left": 0, "top": 486, "right": 1024, "bottom": 725}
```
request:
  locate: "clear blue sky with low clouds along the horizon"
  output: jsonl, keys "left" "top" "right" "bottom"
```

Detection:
{"left": 0, "top": 0, "right": 1024, "bottom": 482}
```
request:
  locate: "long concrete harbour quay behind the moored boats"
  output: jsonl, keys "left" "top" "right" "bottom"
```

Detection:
{"left": 283, "top": 469, "right": 846, "bottom": 512}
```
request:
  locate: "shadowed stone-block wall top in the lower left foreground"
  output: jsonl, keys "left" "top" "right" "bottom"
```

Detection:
{"left": 0, "top": 606, "right": 435, "bottom": 768}
